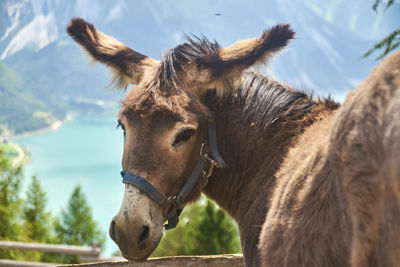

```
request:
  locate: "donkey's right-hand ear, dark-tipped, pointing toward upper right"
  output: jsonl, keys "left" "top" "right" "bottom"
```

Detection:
{"left": 196, "top": 24, "right": 295, "bottom": 82}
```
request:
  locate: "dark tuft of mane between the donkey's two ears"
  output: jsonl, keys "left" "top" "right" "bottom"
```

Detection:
{"left": 157, "top": 36, "right": 221, "bottom": 90}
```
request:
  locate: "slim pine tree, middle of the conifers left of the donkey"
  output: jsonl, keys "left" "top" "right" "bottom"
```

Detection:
{"left": 23, "top": 176, "right": 50, "bottom": 242}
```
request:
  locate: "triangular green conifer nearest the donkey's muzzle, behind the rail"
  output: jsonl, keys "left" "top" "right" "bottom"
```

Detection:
{"left": 54, "top": 186, "right": 105, "bottom": 263}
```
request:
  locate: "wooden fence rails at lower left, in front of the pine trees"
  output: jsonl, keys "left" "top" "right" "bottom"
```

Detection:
{"left": 0, "top": 241, "right": 121, "bottom": 267}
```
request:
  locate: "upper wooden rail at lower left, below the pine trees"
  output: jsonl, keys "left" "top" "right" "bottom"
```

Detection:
{"left": 0, "top": 241, "right": 101, "bottom": 257}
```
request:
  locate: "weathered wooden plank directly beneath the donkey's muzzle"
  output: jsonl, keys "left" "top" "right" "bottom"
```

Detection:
{"left": 60, "top": 254, "right": 244, "bottom": 267}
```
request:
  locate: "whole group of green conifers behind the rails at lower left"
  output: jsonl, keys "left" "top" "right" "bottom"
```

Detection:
{"left": 0, "top": 151, "right": 104, "bottom": 263}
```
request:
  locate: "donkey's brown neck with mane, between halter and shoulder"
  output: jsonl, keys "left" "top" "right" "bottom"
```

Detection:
{"left": 204, "top": 73, "right": 336, "bottom": 266}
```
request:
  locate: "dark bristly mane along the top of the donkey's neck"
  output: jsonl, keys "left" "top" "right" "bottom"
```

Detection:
{"left": 233, "top": 72, "right": 339, "bottom": 129}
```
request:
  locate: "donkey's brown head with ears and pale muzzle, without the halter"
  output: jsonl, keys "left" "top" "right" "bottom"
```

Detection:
{"left": 67, "top": 18, "right": 294, "bottom": 260}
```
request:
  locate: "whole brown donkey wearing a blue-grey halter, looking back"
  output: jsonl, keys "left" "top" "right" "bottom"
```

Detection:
{"left": 67, "top": 18, "right": 400, "bottom": 266}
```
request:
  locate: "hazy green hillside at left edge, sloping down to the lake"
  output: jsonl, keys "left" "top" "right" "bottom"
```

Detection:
{"left": 0, "top": 61, "right": 65, "bottom": 136}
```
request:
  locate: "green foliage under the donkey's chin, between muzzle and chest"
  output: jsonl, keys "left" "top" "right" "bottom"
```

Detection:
{"left": 152, "top": 199, "right": 241, "bottom": 257}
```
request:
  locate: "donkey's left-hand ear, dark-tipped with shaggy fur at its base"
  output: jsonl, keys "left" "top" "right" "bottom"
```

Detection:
{"left": 67, "top": 18, "right": 156, "bottom": 88}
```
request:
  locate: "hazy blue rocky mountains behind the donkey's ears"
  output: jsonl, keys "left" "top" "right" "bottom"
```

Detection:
{"left": 0, "top": 0, "right": 400, "bottom": 135}
